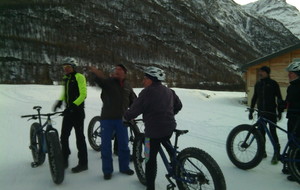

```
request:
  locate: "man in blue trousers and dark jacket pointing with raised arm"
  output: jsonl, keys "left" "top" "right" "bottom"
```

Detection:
{"left": 89, "top": 64, "right": 135, "bottom": 180}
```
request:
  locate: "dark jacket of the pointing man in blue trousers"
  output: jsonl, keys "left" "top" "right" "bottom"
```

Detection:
{"left": 95, "top": 78, "right": 136, "bottom": 120}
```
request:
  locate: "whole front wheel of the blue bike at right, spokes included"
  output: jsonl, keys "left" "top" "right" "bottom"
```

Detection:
{"left": 226, "top": 124, "right": 265, "bottom": 170}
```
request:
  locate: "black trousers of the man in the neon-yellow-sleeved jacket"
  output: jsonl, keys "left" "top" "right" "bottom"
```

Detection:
{"left": 60, "top": 109, "right": 88, "bottom": 165}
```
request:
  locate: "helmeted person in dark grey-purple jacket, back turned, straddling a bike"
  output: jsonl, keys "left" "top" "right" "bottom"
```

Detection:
{"left": 124, "top": 67, "right": 182, "bottom": 190}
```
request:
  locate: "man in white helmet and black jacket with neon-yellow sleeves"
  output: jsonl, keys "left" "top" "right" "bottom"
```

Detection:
{"left": 53, "top": 57, "right": 88, "bottom": 173}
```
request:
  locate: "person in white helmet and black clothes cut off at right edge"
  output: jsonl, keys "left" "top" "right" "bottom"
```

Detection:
{"left": 282, "top": 58, "right": 300, "bottom": 181}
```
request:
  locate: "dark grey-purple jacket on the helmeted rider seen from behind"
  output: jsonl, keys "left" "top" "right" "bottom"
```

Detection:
{"left": 124, "top": 82, "right": 182, "bottom": 138}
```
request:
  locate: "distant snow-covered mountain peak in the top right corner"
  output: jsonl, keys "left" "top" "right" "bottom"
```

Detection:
{"left": 243, "top": 0, "right": 300, "bottom": 38}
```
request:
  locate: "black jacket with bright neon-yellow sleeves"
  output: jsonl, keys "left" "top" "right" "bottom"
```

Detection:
{"left": 60, "top": 72, "right": 87, "bottom": 109}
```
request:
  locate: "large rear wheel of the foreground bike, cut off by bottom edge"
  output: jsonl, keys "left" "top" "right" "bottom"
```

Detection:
{"left": 175, "top": 147, "right": 226, "bottom": 190}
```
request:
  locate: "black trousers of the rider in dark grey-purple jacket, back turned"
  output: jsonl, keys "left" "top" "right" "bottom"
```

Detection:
{"left": 145, "top": 136, "right": 173, "bottom": 190}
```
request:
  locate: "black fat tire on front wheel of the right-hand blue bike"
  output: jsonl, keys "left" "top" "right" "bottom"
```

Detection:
{"left": 226, "top": 124, "right": 265, "bottom": 170}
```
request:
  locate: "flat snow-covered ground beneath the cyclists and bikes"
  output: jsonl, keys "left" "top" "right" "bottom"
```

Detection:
{"left": 0, "top": 85, "right": 300, "bottom": 190}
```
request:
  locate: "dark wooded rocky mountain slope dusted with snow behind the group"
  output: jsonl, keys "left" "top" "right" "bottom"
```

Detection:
{"left": 0, "top": 0, "right": 299, "bottom": 89}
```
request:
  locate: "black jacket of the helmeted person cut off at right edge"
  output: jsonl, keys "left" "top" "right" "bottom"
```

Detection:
{"left": 285, "top": 79, "right": 300, "bottom": 118}
